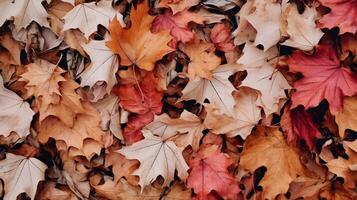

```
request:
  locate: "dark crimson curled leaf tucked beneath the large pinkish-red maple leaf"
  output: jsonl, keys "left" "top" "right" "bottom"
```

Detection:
{"left": 280, "top": 106, "right": 321, "bottom": 150}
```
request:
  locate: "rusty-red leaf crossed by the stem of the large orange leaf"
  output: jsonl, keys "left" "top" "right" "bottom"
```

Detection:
{"left": 113, "top": 72, "right": 164, "bottom": 144}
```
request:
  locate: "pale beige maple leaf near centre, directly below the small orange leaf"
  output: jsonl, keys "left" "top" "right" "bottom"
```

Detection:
{"left": 180, "top": 64, "right": 237, "bottom": 115}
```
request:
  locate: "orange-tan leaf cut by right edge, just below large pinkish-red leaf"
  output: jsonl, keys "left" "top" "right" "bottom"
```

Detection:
{"left": 336, "top": 96, "right": 357, "bottom": 138}
